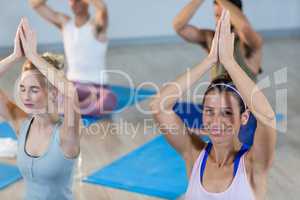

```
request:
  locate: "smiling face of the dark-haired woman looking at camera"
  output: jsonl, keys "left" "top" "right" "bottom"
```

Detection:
{"left": 203, "top": 90, "right": 248, "bottom": 144}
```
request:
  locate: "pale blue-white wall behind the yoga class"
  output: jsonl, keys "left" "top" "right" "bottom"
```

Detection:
{"left": 0, "top": 0, "right": 300, "bottom": 47}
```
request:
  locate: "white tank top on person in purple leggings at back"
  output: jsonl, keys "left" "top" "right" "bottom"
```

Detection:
{"left": 62, "top": 20, "right": 108, "bottom": 84}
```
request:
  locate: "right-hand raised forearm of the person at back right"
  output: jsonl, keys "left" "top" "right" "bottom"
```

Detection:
{"left": 216, "top": 0, "right": 249, "bottom": 30}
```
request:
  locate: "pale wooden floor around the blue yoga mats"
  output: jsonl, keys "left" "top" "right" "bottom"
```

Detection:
{"left": 0, "top": 39, "right": 300, "bottom": 200}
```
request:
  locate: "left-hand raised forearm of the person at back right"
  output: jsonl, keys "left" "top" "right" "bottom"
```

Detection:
{"left": 173, "top": 0, "right": 204, "bottom": 30}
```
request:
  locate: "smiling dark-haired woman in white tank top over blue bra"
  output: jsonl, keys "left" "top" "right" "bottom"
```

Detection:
{"left": 150, "top": 11, "right": 276, "bottom": 200}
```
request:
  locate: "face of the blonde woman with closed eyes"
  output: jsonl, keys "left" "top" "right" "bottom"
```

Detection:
{"left": 19, "top": 70, "right": 48, "bottom": 114}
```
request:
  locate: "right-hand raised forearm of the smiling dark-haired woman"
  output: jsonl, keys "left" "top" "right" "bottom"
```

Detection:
{"left": 224, "top": 60, "right": 275, "bottom": 122}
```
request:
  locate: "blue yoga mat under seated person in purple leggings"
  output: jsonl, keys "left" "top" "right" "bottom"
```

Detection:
{"left": 82, "top": 85, "right": 155, "bottom": 127}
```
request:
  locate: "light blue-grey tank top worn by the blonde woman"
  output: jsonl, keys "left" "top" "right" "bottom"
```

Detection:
{"left": 17, "top": 118, "right": 76, "bottom": 200}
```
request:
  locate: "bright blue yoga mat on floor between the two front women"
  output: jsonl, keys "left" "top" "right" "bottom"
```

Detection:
{"left": 83, "top": 136, "right": 187, "bottom": 199}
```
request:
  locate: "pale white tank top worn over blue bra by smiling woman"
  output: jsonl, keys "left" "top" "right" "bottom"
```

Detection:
{"left": 185, "top": 150, "right": 255, "bottom": 200}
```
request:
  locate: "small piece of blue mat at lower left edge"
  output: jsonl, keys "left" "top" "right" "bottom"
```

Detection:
{"left": 0, "top": 163, "right": 22, "bottom": 190}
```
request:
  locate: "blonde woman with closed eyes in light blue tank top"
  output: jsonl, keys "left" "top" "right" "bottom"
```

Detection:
{"left": 0, "top": 19, "right": 80, "bottom": 200}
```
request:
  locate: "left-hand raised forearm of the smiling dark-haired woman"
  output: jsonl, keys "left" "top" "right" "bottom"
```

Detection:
{"left": 152, "top": 58, "right": 213, "bottom": 110}
